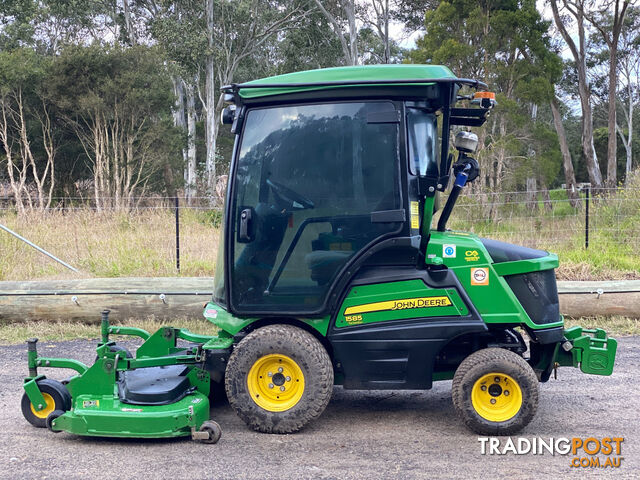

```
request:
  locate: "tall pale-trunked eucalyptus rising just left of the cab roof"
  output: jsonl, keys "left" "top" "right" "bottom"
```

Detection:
{"left": 151, "top": 0, "right": 309, "bottom": 202}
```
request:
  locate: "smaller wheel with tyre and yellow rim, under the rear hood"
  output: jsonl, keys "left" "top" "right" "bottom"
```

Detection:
{"left": 451, "top": 348, "right": 538, "bottom": 435}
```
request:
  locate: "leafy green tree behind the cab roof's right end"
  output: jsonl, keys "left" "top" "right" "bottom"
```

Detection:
{"left": 408, "top": 0, "right": 560, "bottom": 200}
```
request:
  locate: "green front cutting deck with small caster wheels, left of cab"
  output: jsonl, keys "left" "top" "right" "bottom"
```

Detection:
{"left": 22, "top": 310, "right": 222, "bottom": 443}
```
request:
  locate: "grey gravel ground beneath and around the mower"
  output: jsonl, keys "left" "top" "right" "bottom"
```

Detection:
{"left": 0, "top": 337, "right": 640, "bottom": 480}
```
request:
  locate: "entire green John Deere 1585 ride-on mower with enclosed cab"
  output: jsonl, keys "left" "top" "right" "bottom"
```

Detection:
{"left": 23, "top": 65, "right": 617, "bottom": 440}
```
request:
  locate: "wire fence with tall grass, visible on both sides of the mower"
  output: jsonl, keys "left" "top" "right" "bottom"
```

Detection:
{"left": 0, "top": 188, "right": 640, "bottom": 280}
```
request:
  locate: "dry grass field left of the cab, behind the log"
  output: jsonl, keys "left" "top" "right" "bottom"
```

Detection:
{"left": 0, "top": 209, "right": 219, "bottom": 281}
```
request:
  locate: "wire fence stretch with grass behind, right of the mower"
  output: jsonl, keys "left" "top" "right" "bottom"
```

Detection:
{"left": 449, "top": 188, "right": 640, "bottom": 253}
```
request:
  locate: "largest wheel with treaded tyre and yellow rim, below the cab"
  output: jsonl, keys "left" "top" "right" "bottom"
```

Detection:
{"left": 225, "top": 325, "right": 333, "bottom": 433}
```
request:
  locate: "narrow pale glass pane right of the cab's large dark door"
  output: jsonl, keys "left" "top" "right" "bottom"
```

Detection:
{"left": 407, "top": 108, "right": 440, "bottom": 177}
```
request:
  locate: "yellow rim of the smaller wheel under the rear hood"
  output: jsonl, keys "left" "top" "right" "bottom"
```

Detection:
{"left": 471, "top": 372, "right": 522, "bottom": 422}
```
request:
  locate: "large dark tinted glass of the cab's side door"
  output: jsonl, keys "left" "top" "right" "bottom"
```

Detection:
{"left": 232, "top": 102, "right": 400, "bottom": 311}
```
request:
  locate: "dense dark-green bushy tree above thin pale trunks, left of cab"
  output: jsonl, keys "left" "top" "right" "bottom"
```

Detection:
{"left": 39, "top": 45, "right": 183, "bottom": 197}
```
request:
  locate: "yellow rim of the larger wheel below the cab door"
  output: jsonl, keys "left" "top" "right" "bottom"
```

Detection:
{"left": 247, "top": 353, "right": 304, "bottom": 412}
